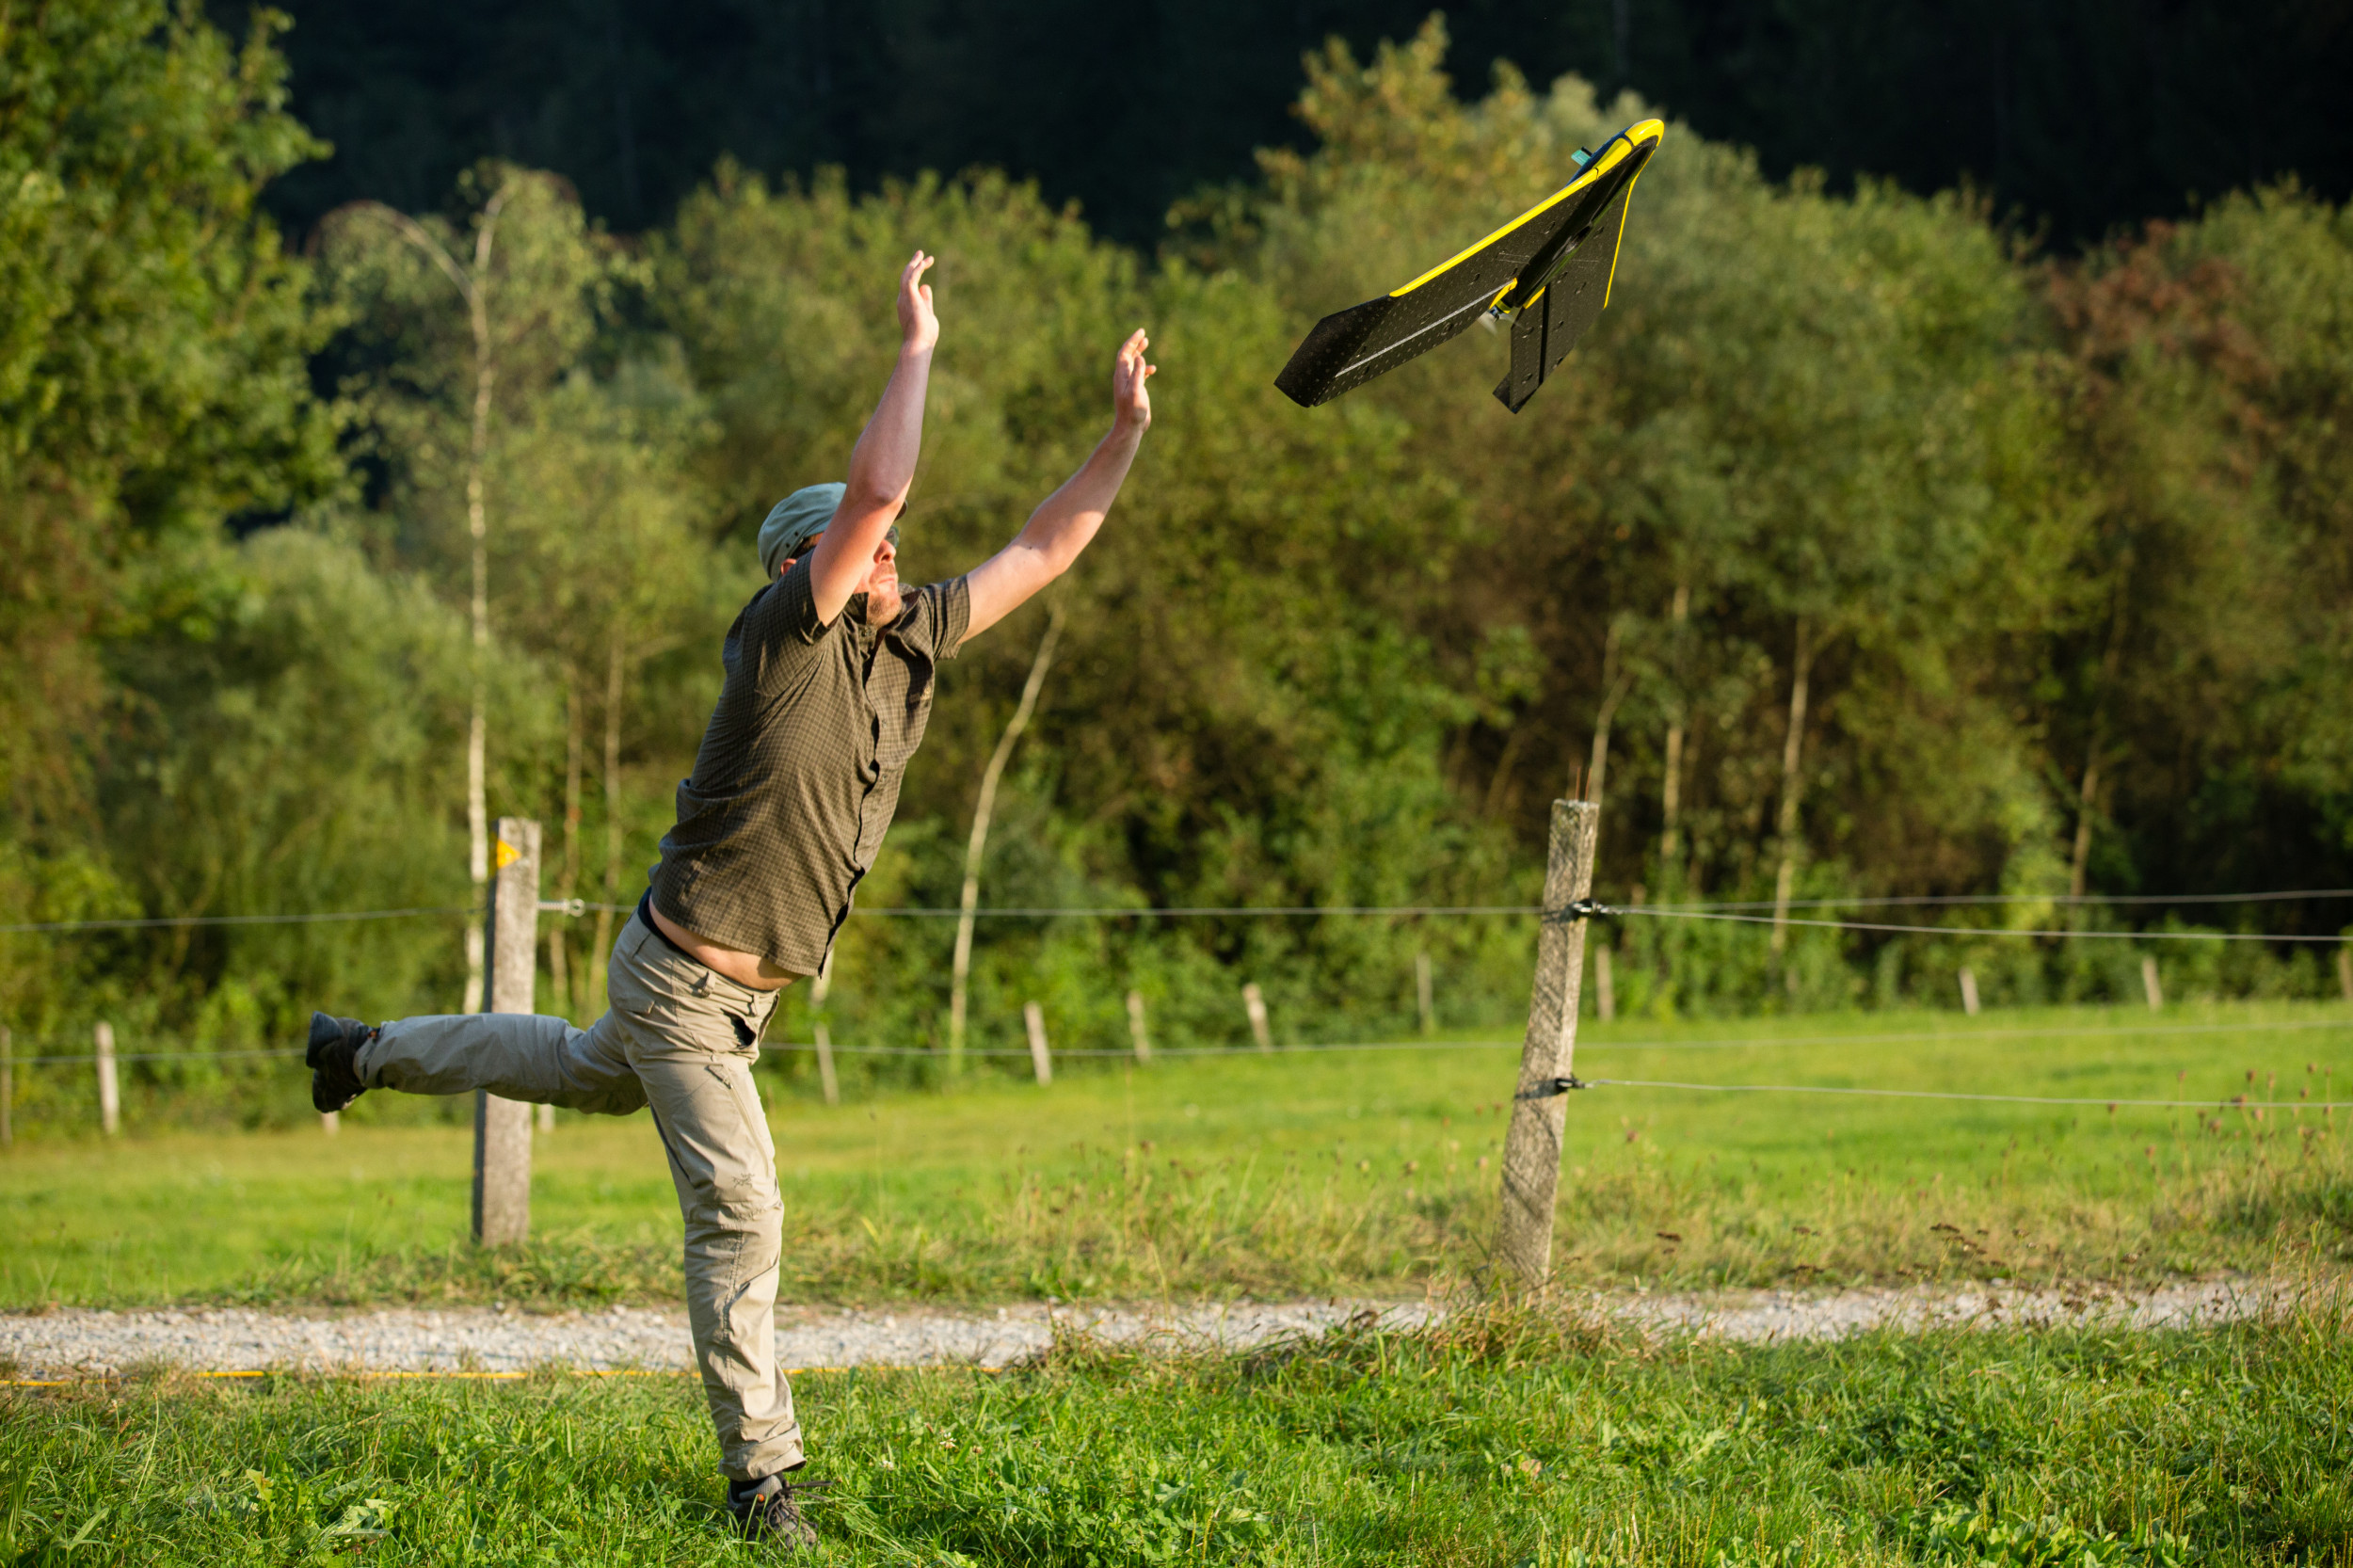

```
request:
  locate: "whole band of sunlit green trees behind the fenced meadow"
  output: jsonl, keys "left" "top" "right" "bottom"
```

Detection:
{"left": 0, "top": 0, "right": 2353, "bottom": 1121}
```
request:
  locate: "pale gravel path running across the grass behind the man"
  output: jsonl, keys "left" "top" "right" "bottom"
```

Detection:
{"left": 0, "top": 1281, "right": 2281, "bottom": 1380}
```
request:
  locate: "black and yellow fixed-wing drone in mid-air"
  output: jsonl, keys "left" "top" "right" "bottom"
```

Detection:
{"left": 1275, "top": 120, "right": 1666, "bottom": 414}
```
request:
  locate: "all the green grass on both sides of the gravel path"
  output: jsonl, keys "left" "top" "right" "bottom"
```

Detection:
{"left": 0, "top": 1005, "right": 2353, "bottom": 1568}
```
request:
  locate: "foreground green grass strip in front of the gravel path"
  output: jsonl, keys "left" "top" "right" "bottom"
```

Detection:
{"left": 0, "top": 1290, "right": 2353, "bottom": 1568}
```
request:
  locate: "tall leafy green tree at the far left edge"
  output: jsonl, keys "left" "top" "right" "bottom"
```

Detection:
{"left": 0, "top": 0, "right": 339, "bottom": 1022}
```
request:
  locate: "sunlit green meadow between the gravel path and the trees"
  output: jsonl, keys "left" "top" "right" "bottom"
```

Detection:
{"left": 0, "top": 1003, "right": 2353, "bottom": 1309}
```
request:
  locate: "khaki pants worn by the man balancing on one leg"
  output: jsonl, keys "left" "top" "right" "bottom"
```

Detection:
{"left": 358, "top": 916, "right": 803, "bottom": 1480}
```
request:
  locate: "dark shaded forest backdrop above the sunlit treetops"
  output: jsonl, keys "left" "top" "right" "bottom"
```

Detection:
{"left": 257, "top": 0, "right": 2353, "bottom": 248}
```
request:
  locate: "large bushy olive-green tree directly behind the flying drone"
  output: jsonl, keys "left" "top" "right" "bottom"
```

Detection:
{"left": 1250, "top": 26, "right": 2073, "bottom": 918}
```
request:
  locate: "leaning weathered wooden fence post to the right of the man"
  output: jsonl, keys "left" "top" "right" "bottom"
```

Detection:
{"left": 1495, "top": 801, "right": 1603, "bottom": 1288}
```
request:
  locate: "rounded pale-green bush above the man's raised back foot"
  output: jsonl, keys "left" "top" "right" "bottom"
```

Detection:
{"left": 102, "top": 530, "right": 482, "bottom": 1041}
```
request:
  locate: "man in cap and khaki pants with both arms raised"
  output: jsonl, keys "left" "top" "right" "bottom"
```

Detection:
{"left": 309, "top": 252, "right": 1153, "bottom": 1544}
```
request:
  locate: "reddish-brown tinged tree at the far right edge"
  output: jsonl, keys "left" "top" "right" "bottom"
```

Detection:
{"left": 2047, "top": 188, "right": 2353, "bottom": 908}
